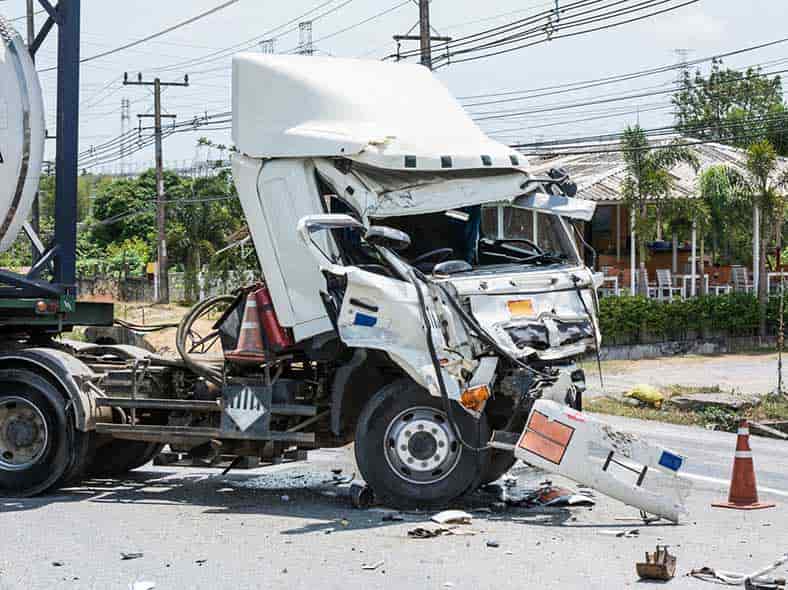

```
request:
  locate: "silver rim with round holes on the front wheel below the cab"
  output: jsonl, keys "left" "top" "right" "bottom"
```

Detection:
{"left": 384, "top": 407, "right": 462, "bottom": 485}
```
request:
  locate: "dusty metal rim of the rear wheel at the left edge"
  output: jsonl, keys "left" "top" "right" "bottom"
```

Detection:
{"left": 0, "top": 397, "right": 49, "bottom": 471}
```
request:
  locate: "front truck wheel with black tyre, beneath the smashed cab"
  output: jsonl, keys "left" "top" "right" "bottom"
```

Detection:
{"left": 355, "top": 379, "right": 490, "bottom": 508}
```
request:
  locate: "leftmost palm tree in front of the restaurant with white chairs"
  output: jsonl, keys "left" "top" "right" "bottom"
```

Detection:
{"left": 621, "top": 125, "right": 698, "bottom": 292}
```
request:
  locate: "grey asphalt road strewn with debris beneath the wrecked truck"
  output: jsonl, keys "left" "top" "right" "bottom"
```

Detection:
{"left": 0, "top": 419, "right": 788, "bottom": 590}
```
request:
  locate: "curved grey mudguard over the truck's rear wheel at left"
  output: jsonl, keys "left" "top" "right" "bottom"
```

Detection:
{"left": 0, "top": 348, "right": 96, "bottom": 431}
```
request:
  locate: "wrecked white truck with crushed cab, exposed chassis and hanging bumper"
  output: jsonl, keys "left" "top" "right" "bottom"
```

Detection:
{"left": 0, "top": 34, "right": 684, "bottom": 520}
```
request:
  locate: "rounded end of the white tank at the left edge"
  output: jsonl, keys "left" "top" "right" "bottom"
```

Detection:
{"left": 0, "top": 16, "right": 46, "bottom": 252}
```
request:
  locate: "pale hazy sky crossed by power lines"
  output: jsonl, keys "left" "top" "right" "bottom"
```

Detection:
{"left": 0, "top": 0, "right": 788, "bottom": 172}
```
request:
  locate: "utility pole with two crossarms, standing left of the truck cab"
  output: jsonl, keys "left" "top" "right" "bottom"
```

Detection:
{"left": 123, "top": 72, "right": 189, "bottom": 303}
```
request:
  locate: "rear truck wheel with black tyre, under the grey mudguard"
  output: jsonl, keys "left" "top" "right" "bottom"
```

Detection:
{"left": 0, "top": 369, "right": 90, "bottom": 496}
